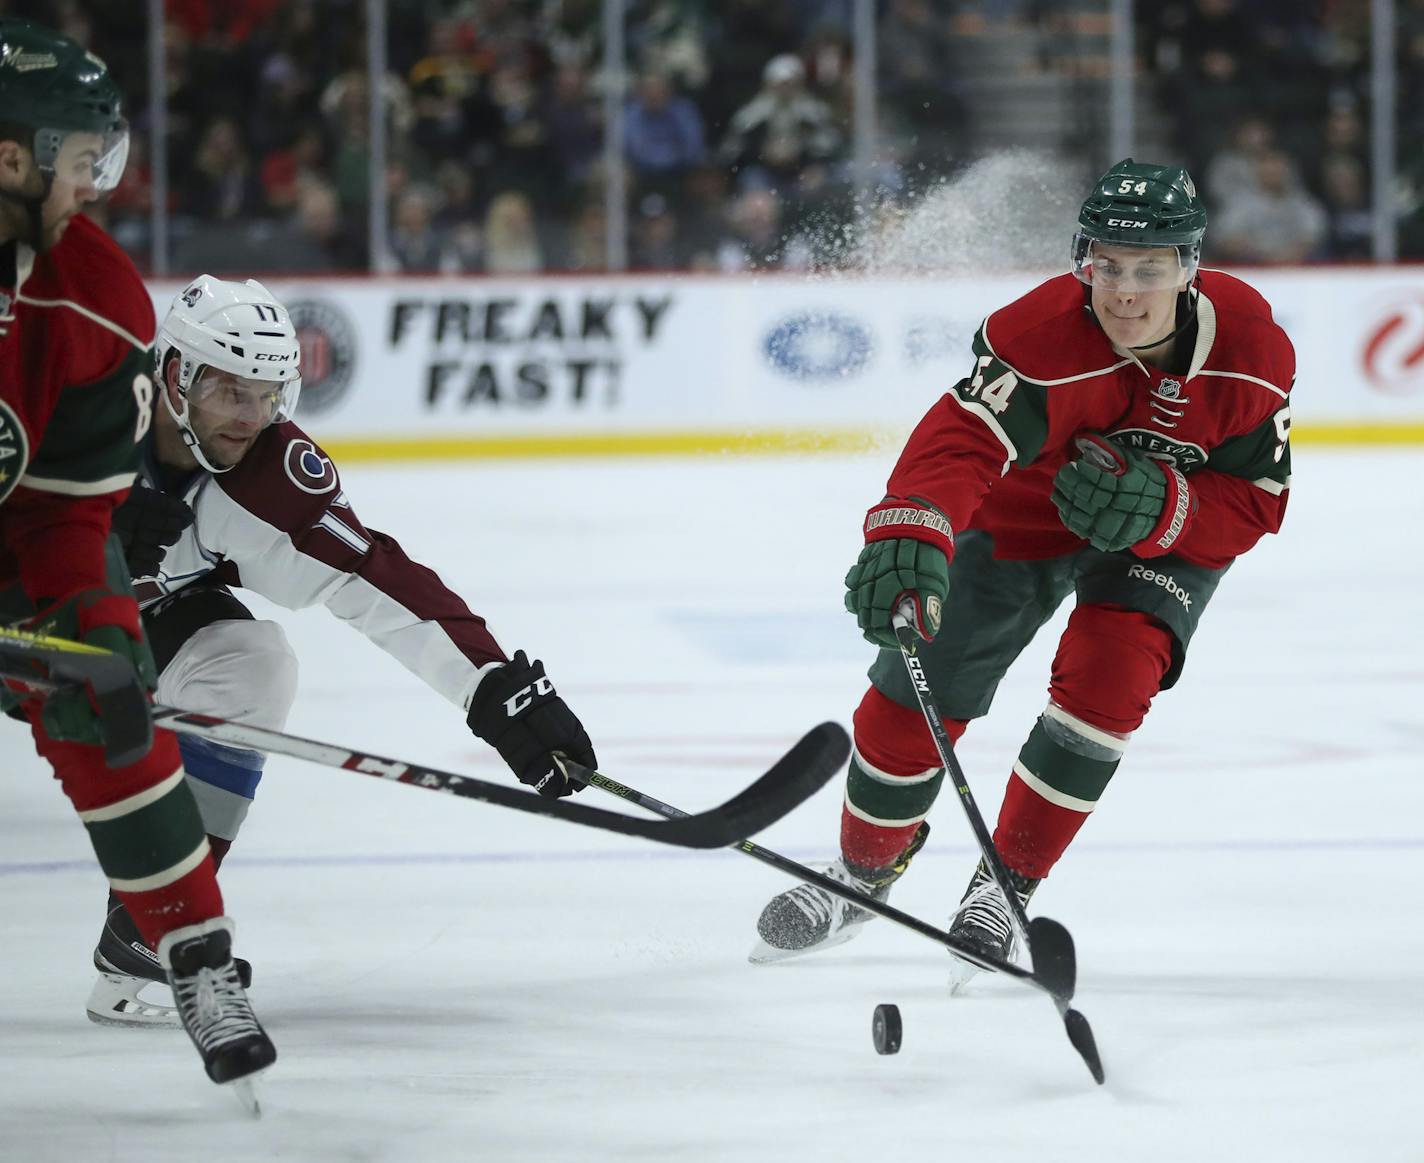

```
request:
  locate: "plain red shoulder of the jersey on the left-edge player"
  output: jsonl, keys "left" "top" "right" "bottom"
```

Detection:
{"left": 37, "top": 214, "right": 157, "bottom": 347}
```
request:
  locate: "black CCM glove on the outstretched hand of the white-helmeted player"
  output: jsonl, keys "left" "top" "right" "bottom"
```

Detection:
{"left": 467, "top": 651, "right": 598, "bottom": 799}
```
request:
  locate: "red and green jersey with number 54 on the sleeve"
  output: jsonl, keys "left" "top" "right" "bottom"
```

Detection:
{"left": 889, "top": 270, "right": 1296, "bottom": 568}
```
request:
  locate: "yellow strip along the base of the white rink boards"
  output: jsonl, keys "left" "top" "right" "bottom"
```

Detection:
{"left": 322, "top": 423, "right": 1424, "bottom": 461}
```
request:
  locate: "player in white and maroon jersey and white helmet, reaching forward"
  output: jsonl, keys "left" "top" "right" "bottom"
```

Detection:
{"left": 88, "top": 275, "right": 597, "bottom": 1025}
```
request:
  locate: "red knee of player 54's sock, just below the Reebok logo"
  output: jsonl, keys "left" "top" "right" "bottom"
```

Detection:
{"left": 1048, "top": 605, "right": 1172, "bottom": 736}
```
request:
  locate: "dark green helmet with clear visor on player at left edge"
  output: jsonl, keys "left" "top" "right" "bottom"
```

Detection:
{"left": 0, "top": 17, "right": 128, "bottom": 191}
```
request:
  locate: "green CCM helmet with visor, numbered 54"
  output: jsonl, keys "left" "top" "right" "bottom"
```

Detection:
{"left": 1072, "top": 158, "right": 1206, "bottom": 290}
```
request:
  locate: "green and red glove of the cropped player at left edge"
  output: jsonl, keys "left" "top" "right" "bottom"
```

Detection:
{"left": 26, "top": 586, "right": 158, "bottom": 744}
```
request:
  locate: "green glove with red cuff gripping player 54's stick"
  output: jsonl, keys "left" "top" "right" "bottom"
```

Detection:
{"left": 846, "top": 498, "right": 954, "bottom": 651}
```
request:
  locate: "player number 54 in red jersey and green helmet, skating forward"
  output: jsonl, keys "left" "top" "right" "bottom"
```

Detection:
{"left": 752, "top": 158, "right": 1294, "bottom": 962}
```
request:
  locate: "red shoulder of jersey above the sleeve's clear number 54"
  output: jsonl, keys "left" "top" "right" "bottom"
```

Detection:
{"left": 984, "top": 275, "right": 1122, "bottom": 383}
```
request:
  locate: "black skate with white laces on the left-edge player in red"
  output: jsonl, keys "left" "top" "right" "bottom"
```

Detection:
{"left": 158, "top": 917, "right": 276, "bottom": 1112}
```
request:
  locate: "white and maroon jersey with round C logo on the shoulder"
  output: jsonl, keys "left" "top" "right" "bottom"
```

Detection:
{"left": 134, "top": 423, "right": 507, "bottom": 707}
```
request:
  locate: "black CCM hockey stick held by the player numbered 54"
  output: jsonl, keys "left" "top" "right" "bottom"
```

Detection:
{"left": 893, "top": 599, "right": 1102, "bottom": 1082}
